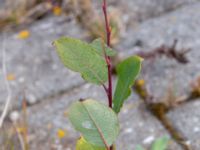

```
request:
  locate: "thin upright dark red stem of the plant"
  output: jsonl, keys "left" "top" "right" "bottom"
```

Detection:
{"left": 102, "top": 0, "right": 112, "bottom": 108}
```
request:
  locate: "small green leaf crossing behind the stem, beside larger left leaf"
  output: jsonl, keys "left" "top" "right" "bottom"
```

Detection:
{"left": 91, "top": 38, "right": 117, "bottom": 56}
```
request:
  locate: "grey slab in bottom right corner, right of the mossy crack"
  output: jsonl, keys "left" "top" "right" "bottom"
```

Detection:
{"left": 167, "top": 100, "right": 200, "bottom": 150}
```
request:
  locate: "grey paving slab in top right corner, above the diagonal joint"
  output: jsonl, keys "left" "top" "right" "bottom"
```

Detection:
{"left": 120, "top": 0, "right": 196, "bottom": 21}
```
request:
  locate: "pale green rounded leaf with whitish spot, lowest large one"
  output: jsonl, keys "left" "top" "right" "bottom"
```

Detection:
{"left": 69, "top": 99, "right": 119, "bottom": 147}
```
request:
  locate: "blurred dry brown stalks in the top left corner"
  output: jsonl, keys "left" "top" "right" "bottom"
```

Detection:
{"left": 0, "top": 0, "right": 52, "bottom": 29}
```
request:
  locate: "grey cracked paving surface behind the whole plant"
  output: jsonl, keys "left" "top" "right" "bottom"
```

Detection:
{"left": 0, "top": 0, "right": 200, "bottom": 150}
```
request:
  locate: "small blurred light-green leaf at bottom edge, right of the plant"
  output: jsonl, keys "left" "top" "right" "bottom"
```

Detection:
{"left": 151, "top": 136, "right": 169, "bottom": 150}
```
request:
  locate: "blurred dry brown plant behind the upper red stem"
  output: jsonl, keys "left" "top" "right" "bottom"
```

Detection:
{"left": 63, "top": 0, "right": 123, "bottom": 45}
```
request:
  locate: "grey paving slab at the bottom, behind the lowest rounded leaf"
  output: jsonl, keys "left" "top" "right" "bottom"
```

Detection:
{"left": 20, "top": 84, "right": 181, "bottom": 150}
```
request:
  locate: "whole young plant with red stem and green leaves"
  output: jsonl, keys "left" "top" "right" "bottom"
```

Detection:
{"left": 54, "top": 0, "right": 142, "bottom": 150}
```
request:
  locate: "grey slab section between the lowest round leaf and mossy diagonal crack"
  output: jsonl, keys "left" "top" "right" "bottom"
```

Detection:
{"left": 117, "top": 103, "right": 181, "bottom": 150}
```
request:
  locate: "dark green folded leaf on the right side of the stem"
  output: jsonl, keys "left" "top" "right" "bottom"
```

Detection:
{"left": 113, "top": 56, "right": 142, "bottom": 113}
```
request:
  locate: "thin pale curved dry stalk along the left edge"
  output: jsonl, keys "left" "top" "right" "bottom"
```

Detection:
{"left": 0, "top": 32, "right": 12, "bottom": 128}
